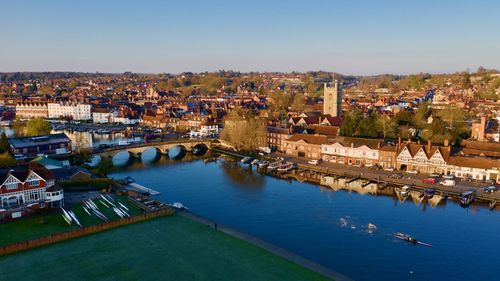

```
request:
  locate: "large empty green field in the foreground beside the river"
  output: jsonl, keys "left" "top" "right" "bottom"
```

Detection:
{"left": 0, "top": 215, "right": 329, "bottom": 281}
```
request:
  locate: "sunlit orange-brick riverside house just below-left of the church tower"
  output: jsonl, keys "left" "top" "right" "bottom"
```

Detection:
{"left": 283, "top": 134, "right": 328, "bottom": 159}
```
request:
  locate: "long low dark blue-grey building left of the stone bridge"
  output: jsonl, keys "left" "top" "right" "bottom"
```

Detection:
{"left": 9, "top": 133, "right": 71, "bottom": 157}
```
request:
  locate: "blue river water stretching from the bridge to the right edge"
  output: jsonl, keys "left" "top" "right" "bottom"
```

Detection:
{"left": 111, "top": 159, "right": 500, "bottom": 281}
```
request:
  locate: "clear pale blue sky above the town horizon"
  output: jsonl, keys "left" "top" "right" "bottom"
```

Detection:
{"left": 0, "top": 0, "right": 500, "bottom": 74}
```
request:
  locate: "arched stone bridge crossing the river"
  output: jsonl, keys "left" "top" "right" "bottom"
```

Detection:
{"left": 94, "top": 139, "right": 217, "bottom": 158}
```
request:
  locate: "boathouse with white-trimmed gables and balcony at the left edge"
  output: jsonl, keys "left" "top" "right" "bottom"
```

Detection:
{"left": 0, "top": 164, "right": 64, "bottom": 218}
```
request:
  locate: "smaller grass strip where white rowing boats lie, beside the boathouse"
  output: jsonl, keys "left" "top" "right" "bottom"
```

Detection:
{"left": 0, "top": 196, "right": 141, "bottom": 246}
